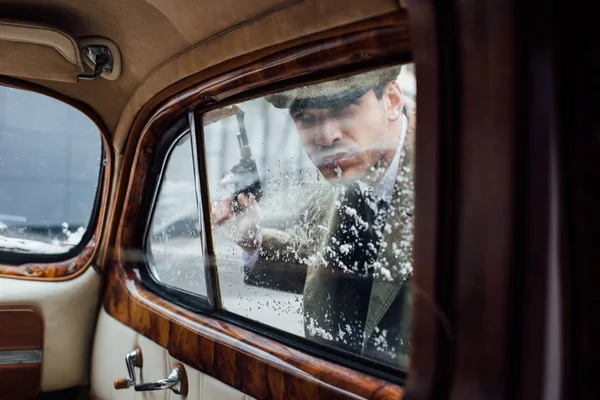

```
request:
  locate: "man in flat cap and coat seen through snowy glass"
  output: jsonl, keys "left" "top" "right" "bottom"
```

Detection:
{"left": 213, "top": 67, "right": 416, "bottom": 368}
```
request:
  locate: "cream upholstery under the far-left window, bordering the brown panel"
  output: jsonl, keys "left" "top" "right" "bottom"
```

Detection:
{"left": 0, "top": 267, "right": 101, "bottom": 391}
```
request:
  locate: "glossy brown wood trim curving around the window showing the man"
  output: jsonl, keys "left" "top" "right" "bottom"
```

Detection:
{"left": 104, "top": 12, "right": 412, "bottom": 399}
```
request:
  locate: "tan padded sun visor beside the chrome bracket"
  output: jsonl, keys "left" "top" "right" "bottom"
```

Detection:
{"left": 0, "top": 20, "right": 83, "bottom": 82}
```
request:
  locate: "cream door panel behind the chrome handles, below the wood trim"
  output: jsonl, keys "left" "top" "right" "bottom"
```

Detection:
{"left": 91, "top": 309, "right": 252, "bottom": 400}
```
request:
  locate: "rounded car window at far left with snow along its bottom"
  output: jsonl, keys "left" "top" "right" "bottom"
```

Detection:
{"left": 0, "top": 85, "right": 103, "bottom": 254}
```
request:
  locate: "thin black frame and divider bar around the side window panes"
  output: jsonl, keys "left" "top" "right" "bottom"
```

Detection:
{"left": 139, "top": 58, "right": 412, "bottom": 386}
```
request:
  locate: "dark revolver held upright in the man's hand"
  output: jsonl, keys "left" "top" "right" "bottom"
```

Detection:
{"left": 229, "top": 108, "right": 262, "bottom": 212}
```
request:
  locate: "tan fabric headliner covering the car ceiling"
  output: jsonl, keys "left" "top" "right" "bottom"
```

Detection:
{"left": 0, "top": 0, "right": 399, "bottom": 152}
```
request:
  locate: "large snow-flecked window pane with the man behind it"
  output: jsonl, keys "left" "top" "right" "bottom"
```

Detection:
{"left": 203, "top": 65, "right": 416, "bottom": 369}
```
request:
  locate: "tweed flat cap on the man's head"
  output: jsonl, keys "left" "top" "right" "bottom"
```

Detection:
{"left": 265, "top": 66, "right": 402, "bottom": 109}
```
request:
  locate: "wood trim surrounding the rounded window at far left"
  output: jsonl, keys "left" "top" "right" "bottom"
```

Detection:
{"left": 0, "top": 75, "right": 114, "bottom": 281}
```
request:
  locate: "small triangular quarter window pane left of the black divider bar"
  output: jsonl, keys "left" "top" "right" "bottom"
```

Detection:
{"left": 146, "top": 132, "right": 206, "bottom": 296}
